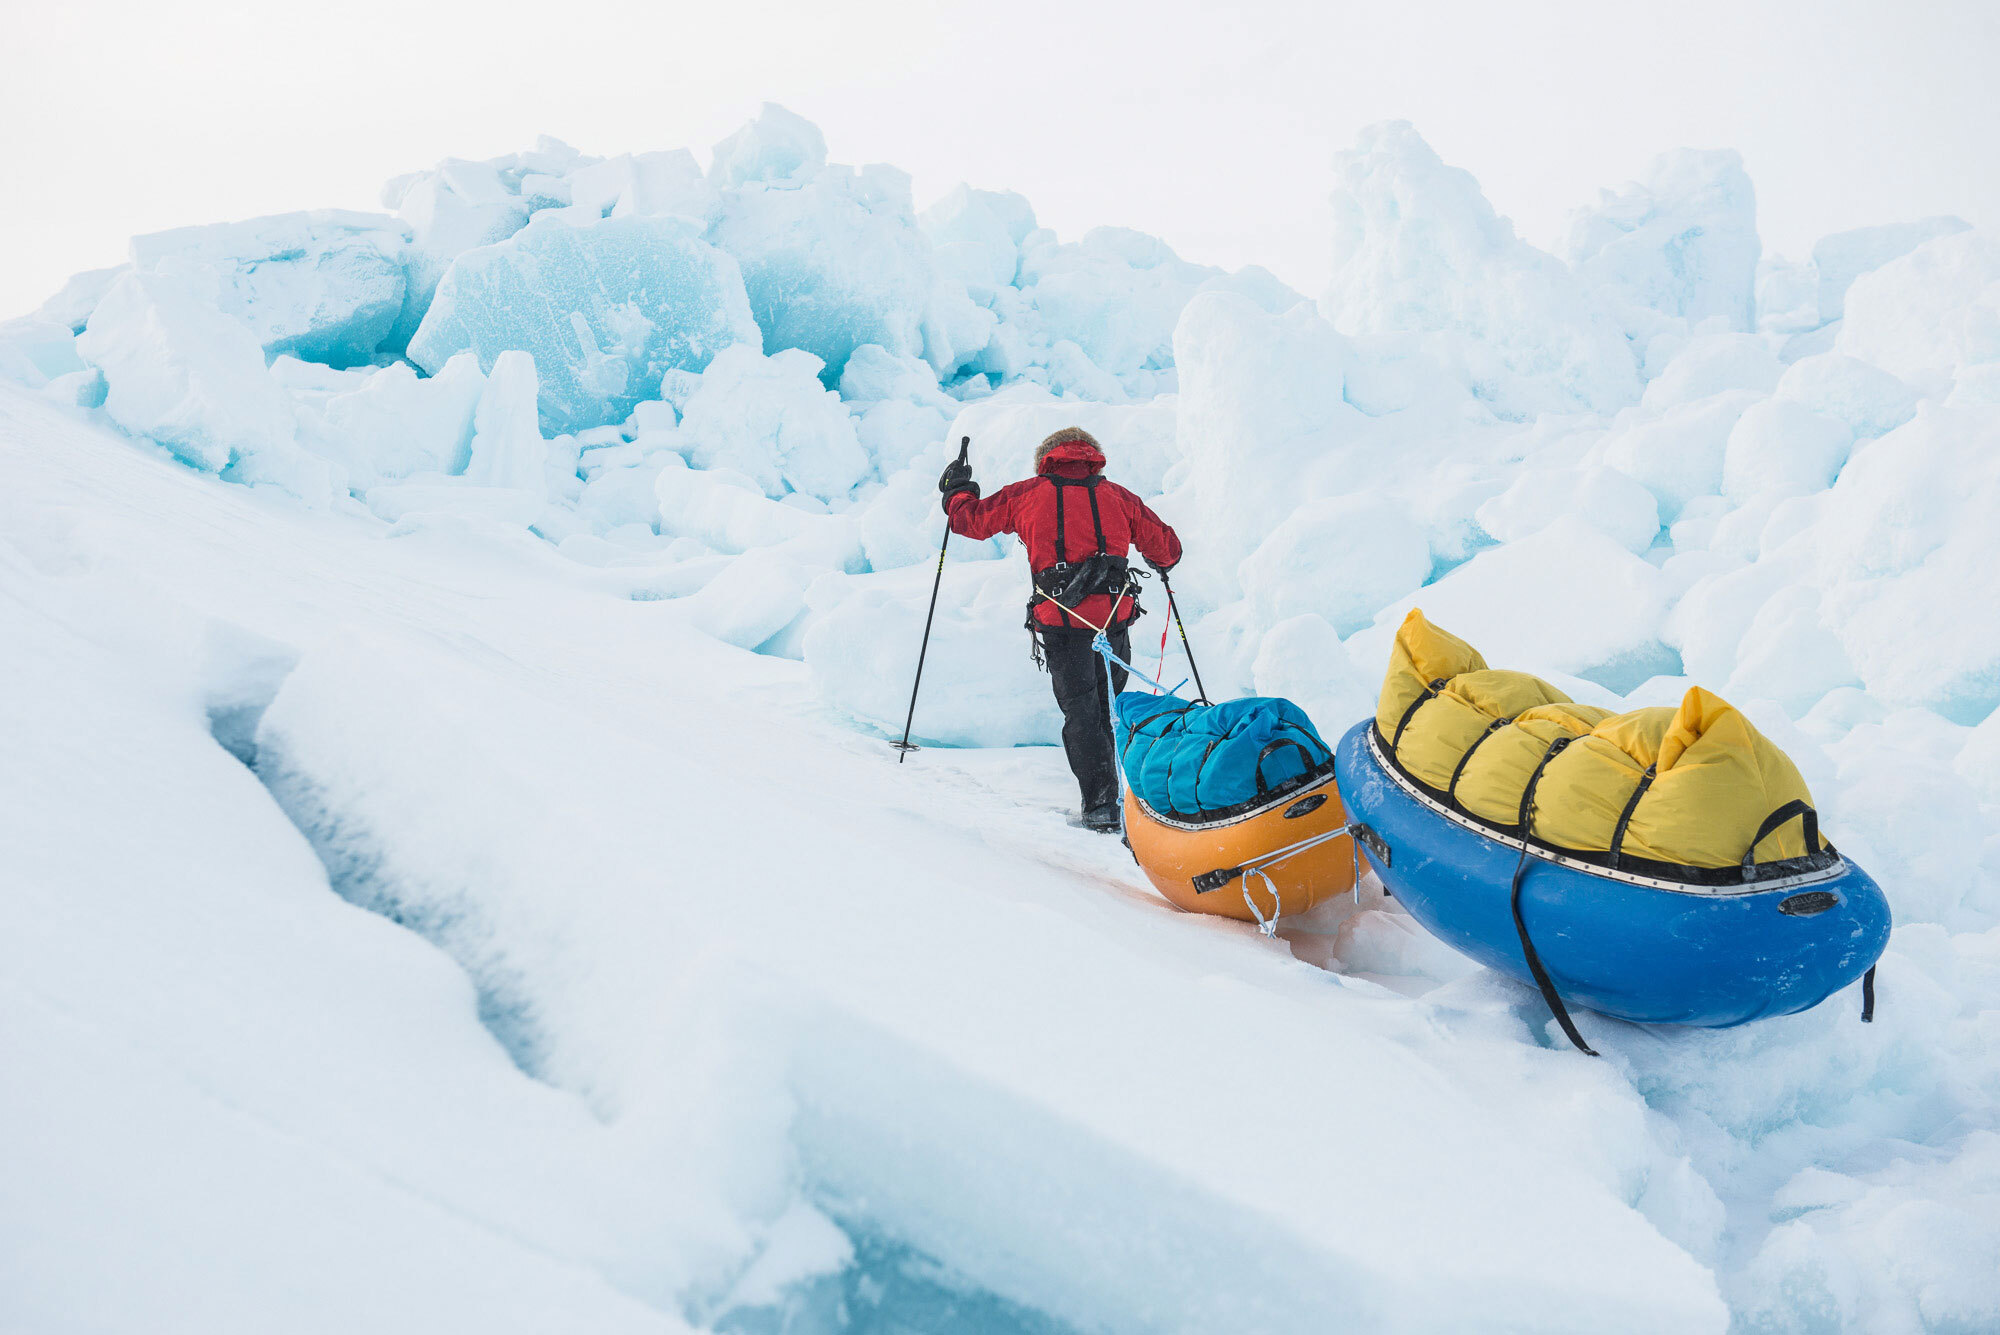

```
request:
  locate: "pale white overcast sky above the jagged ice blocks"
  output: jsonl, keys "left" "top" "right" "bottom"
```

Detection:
{"left": 0, "top": 0, "right": 2000, "bottom": 318}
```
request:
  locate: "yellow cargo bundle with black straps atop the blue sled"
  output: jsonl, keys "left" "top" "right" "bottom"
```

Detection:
{"left": 1376, "top": 612, "right": 1814, "bottom": 867}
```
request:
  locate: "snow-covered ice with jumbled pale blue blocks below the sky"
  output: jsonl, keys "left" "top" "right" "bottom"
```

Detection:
{"left": 0, "top": 108, "right": 2000, "bottom": 1331}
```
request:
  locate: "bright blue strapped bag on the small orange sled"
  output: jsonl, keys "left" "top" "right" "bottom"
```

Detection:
{"left": 1112, "top": 691, "right": 1334, "bottom": 821}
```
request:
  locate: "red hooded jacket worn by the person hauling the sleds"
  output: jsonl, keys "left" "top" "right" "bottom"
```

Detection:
{"left": 946, "top": 440, "right": 1180, "bottom": 630}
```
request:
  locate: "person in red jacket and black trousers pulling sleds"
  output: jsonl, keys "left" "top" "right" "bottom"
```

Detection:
{"left": 938, "top": 426, "right": 1180, "bottom": 831}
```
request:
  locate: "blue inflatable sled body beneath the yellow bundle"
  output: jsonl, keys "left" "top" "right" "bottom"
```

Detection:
{"left": 1336, "top": 721, "right": 1890, "bottom": 1051}
